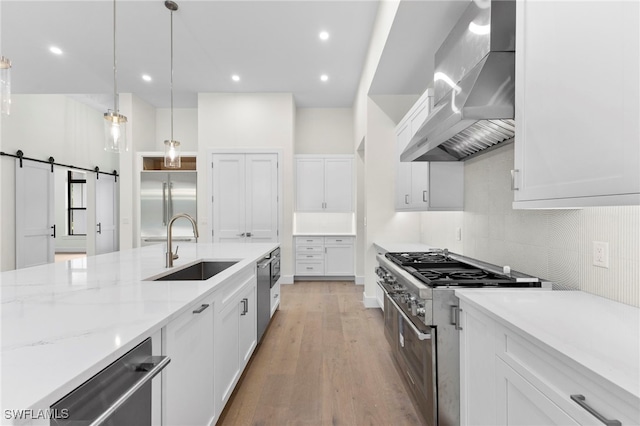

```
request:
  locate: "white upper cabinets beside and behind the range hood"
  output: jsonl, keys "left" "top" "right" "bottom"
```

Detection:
{"left": 395, "top": 89, "right": 464, "bottom": 211}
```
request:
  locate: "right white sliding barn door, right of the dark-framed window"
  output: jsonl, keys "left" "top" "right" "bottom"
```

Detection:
{"left": 95, "top": 175, "right": 118, "bottom": 254}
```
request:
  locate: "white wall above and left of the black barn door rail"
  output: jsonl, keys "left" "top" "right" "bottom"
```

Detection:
{"left": 0, "top": 94, "right": 118, "bottom": 271}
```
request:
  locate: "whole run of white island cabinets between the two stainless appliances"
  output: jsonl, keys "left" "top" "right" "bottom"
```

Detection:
{"left": 162, "top": 264, "right": 257, "bottom": 426}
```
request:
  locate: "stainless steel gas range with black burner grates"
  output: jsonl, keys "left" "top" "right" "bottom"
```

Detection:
{"left": 376, "top": 249, "right": 551, "bottom": 426}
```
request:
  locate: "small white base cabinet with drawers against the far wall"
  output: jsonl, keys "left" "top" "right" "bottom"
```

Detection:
{"left": 295, "top": 236, "right": 355, "bottom": 276}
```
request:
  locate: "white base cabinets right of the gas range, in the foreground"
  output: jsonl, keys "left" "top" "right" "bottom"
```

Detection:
{"left": 460, "top": 300, "right": 640, "bottom": 425}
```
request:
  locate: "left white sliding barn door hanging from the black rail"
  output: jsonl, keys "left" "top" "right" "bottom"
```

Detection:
{"left": 15, "top": 160, "right": 56, "bottom": 269}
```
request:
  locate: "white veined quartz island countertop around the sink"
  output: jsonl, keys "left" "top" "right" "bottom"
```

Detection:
{"left": 0, "top": 243, "right": 278, "bottom": 416}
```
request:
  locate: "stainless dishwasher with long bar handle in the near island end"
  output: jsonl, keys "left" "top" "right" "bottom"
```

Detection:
{"left": 50, "top": 338, "right": 171, "bottom": 426}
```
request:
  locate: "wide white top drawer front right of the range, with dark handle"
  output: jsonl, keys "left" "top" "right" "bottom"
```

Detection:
{"left": 497, "top": 329, "right": 640, "bottom": 424}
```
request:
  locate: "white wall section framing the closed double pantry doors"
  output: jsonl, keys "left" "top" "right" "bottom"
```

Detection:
{"left": 198, "top": 93, "right": 296, "bottom": 279}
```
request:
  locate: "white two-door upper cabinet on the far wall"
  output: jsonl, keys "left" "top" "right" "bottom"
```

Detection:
{"left": 296, "top": 155, "right": 353, "bottom": 212}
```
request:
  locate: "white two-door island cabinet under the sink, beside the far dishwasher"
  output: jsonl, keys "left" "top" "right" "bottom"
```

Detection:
{"left": 214, "top": 265, "right": 257, "bottom": 417}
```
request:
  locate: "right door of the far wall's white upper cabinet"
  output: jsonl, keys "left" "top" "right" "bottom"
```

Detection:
{"left": 324, "top": 158, "right": 353, "bottom": 212}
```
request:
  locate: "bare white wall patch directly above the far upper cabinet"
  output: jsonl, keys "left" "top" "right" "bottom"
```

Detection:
{"left": 295, "top": 108, "right": 354, "bottom": 154}
